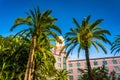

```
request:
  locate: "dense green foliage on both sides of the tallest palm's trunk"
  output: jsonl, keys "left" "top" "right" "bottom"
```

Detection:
{"left": 0, "top": 35, "right": 61, "bottom": 80}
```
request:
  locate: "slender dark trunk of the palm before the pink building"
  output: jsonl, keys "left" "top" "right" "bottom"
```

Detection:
{"left": 85, "top": 42, "right": 93, "bottom": 80}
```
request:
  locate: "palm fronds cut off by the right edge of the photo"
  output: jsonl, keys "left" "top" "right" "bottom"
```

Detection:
{"left": 111, "top": 35, "right": 120, "bottom": 55}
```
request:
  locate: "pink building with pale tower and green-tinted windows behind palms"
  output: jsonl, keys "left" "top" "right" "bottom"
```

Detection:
{"left": 53, "top": 36, "right": 120, "bottom": 80}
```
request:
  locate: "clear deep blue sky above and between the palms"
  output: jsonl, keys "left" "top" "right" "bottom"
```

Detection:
{"left": 0, "top": 0, "right": 120, "bottom": 59}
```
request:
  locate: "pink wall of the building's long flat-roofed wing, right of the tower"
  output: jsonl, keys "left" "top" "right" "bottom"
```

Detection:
{"left": 67, "top": 56, "right": 120, "bottom": 80}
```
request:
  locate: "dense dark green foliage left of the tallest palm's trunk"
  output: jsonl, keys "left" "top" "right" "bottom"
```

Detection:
{"left": 0, "top": 36, "right": 29, "bottom": 80}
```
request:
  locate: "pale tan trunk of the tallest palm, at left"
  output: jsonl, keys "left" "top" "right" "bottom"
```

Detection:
{"left": 24, "top": 36, "right": 36, "bottom": 80}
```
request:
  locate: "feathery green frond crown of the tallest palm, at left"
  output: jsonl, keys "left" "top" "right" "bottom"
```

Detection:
{"left": 10, "top": 7, "right": 61, "bottom": 41}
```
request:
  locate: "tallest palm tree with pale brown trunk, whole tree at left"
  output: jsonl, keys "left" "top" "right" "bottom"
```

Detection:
{"left": 10, "top": 7, "right": 61, "bottom": 80}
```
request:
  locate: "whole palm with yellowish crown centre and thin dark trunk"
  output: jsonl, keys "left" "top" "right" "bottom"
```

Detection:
{"left": 62, "top": 16, "right": 110, "bottom": 80}
